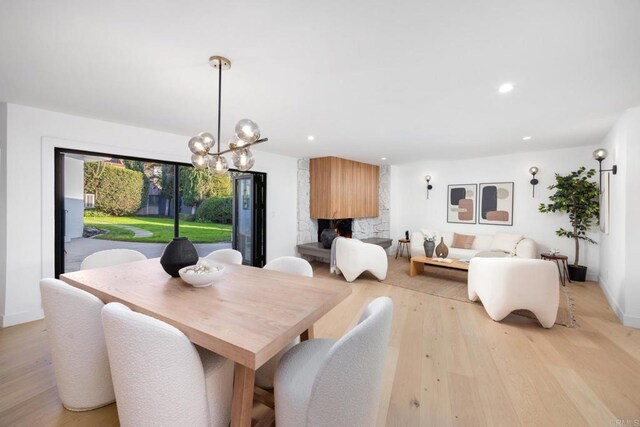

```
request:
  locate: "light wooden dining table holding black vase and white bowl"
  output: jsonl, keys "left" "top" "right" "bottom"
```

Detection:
{"left": 60, "top": 258, "right": 351, "bottom": 426}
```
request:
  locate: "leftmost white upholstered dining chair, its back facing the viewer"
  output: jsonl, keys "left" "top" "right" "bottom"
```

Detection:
{"left": 40, "top": 279, "right": 115, "bottom": 411}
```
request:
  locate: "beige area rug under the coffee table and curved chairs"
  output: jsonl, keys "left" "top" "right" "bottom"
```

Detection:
{"left": 313, "top": 257, "right": 576, "bottom": 328}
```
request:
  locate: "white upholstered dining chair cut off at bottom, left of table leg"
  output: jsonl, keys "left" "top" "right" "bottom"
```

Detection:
{"left": 102, "top": 303, "right": 233, "bottom": 427}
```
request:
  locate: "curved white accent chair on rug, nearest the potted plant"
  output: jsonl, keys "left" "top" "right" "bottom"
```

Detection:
{"left": 468, "top": 258, "right": 560, "bottom": 328}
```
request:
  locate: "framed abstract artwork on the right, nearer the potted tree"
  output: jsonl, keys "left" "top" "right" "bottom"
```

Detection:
{"left": 478, "top": 182, "right": 513, "bottom": 225}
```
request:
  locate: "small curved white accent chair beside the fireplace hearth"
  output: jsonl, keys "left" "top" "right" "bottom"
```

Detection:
{"left": 336, "top": 238, "right": 389, "bottom": 282}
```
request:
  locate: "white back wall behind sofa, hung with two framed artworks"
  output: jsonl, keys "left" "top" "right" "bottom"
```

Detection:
{"left": 391, "top": 142, "right": 599, "bottom": 279}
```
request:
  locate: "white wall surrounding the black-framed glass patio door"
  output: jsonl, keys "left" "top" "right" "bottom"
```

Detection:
{"left": 0, "top": 104, "right": 297, "bottom": 326}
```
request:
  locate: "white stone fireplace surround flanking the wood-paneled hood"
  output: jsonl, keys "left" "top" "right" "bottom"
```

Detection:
{"left": 297, "top": 159, "right": 391, "bottom": 252}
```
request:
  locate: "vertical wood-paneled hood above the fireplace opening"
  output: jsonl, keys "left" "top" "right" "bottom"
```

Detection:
{"left": 309, "top": 157, "right": 380, "bottom": 219}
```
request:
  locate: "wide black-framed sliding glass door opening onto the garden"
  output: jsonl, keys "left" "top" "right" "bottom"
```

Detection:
{"left": 54, "top": 149, "right": 266, "bottom": 277}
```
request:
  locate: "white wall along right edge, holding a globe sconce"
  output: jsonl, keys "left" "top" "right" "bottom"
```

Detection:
{"left": 600, "top": 108, "right": 640, "bottom": 328}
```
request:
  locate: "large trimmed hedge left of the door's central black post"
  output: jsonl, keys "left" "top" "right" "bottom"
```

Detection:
{"left": 84, "top": 162, "right": 144, "bottom": 216}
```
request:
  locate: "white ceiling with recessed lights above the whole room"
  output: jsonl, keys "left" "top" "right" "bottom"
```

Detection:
{"left": 0, "top": 0, "right": 640, "bottom": 163}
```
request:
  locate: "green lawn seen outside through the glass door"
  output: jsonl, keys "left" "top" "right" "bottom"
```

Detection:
{"left": 84, "top": 216, "right": 231, "bottom": 243}
